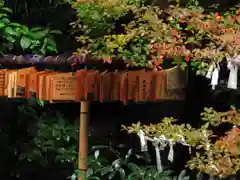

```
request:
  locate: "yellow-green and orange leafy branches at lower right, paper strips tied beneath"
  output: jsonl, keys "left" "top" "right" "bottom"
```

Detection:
{"left": 123, "top": 108, "right": 240, "bottom": 178}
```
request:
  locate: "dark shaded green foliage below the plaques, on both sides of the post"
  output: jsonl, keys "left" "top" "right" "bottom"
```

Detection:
{"left": 14, "top": 104, "right": 189, "bottom": 180}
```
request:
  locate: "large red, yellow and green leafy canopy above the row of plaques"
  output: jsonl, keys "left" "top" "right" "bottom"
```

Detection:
{"left": 64, "top": 0, "right": 240, "bottom": 74}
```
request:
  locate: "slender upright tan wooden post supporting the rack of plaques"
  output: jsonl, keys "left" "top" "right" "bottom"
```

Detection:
{"left": 78, "top": 101, "right": 89, "bottom": 180}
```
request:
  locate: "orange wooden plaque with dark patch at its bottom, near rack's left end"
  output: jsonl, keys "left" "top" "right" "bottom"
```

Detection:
{"left": 16, "top": 67, "right": 37, "bottom": 98}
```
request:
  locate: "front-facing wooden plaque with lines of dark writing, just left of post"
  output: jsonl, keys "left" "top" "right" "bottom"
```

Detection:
{"left": 51, "top": 73, "right": 76, "bottom": 101}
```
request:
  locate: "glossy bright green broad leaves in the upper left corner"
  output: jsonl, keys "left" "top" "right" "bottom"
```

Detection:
{"left": 0, "top": 6, "right": 61, "bottom": 54}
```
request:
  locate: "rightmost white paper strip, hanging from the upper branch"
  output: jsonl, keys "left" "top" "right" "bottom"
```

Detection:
{"left": 227, "top": 61, "right": 238, "bottom": 89}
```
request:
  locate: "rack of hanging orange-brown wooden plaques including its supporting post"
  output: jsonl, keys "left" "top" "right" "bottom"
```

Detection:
{"left": 0, "top": 60, "right": 186, "bottom": 180}
